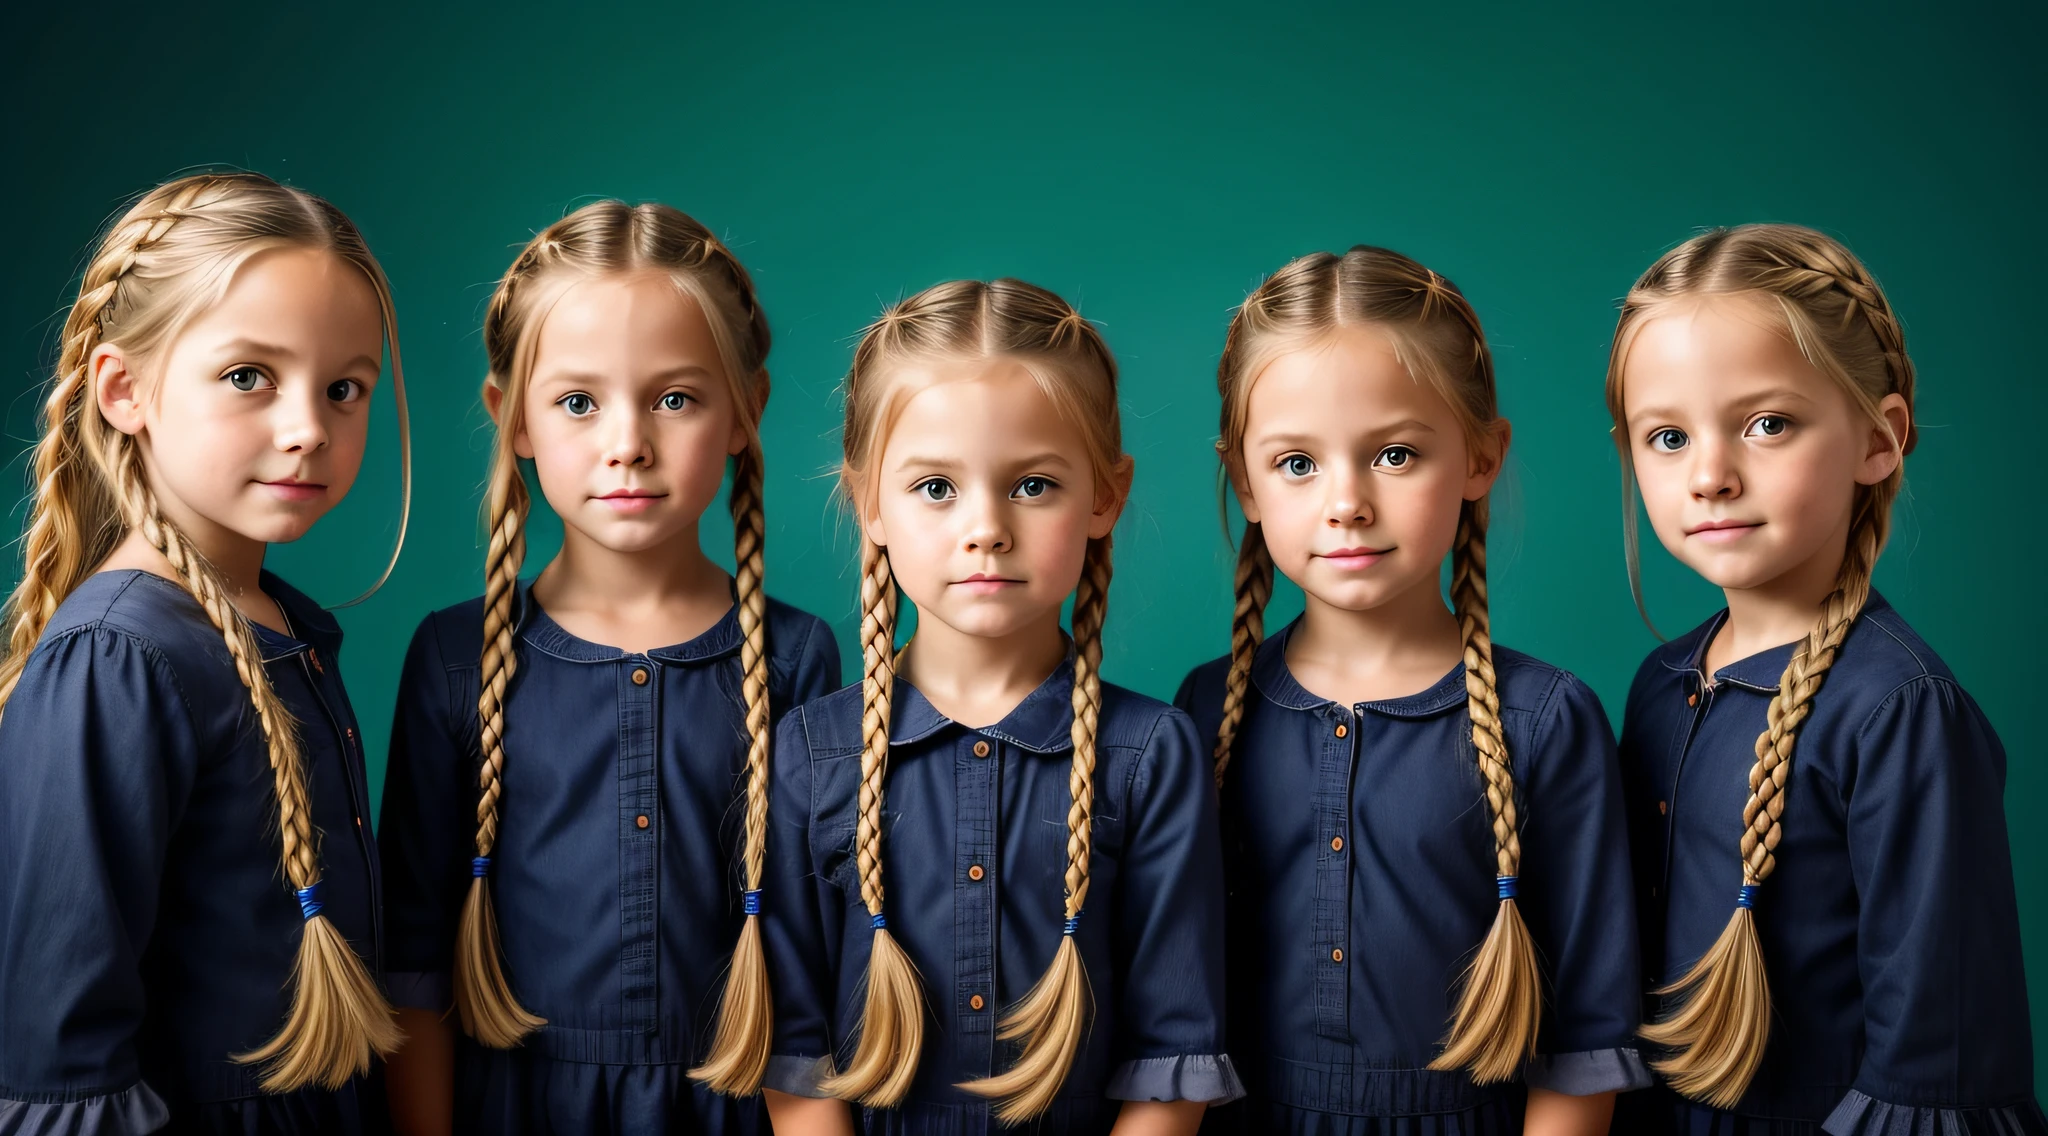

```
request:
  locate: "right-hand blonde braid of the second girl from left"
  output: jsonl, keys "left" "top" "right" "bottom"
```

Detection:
{"left": 690, "top": 442, "right": 774, "bottom": 1097}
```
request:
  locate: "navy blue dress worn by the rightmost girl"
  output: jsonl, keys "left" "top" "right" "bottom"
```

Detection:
{"left": 1616, "top": 594, "right": 2048, "bottom": 1136}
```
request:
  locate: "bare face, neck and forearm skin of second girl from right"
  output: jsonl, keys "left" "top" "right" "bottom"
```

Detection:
{"left": 1225, "top": 325, "right": 1614, "bottom": 1136}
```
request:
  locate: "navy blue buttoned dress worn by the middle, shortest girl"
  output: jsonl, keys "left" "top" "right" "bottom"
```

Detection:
{"left": 762, "top": 659, "right": 1241, "bottom": 1136}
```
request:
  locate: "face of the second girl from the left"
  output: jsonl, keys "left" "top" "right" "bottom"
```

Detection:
{"left": 512, "top": 272, "right": 748, "bottom": 553}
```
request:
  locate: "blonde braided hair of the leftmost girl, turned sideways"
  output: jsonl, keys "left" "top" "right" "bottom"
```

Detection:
{"left": 0, "top": 174, "right": 412, "bottom": 1093}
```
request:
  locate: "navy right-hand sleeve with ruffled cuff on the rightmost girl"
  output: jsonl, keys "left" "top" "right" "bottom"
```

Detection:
{"left": 1827, "top": 678, "right": 2048, "bottom": 1136}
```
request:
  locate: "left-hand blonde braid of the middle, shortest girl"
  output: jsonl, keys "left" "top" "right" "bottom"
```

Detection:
{"left": 819, "top": 534, "right": 924, "bottom": 1107}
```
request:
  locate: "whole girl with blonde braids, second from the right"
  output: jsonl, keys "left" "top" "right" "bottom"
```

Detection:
{"left": 1178, "top": 246, "right": 1649, "bottom": 1136}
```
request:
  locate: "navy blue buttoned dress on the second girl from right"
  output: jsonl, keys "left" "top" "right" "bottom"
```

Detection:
{"left": 1176, "top": 620, "right": 1651, "bottom": 1136}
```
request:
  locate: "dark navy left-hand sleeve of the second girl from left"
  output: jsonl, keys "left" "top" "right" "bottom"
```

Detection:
{"left": 377, "top": 616, "right": 477, "bottom": 1011}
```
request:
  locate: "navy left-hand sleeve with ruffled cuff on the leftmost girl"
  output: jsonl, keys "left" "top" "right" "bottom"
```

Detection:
{"left": 0, "top": 628, "right": 201, "bottom": 1134}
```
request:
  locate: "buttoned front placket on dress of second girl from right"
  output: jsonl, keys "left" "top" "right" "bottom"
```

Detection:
{"left": 1313, "top": 704, "right": 1358, "bottom": 1042}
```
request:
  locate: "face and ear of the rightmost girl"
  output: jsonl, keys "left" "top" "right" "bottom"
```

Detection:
{"left": 1622, "top": 297, "right": 1907, "bottom": 589}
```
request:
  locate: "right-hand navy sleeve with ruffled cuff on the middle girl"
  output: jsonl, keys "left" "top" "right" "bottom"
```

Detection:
{"left": 1104, "top": 710, "right": 1243, "bottom": 1103}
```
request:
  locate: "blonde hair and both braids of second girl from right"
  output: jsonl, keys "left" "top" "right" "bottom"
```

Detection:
{"left": 1217, "top": 246, "right": 1542, "bottom": 1083}
